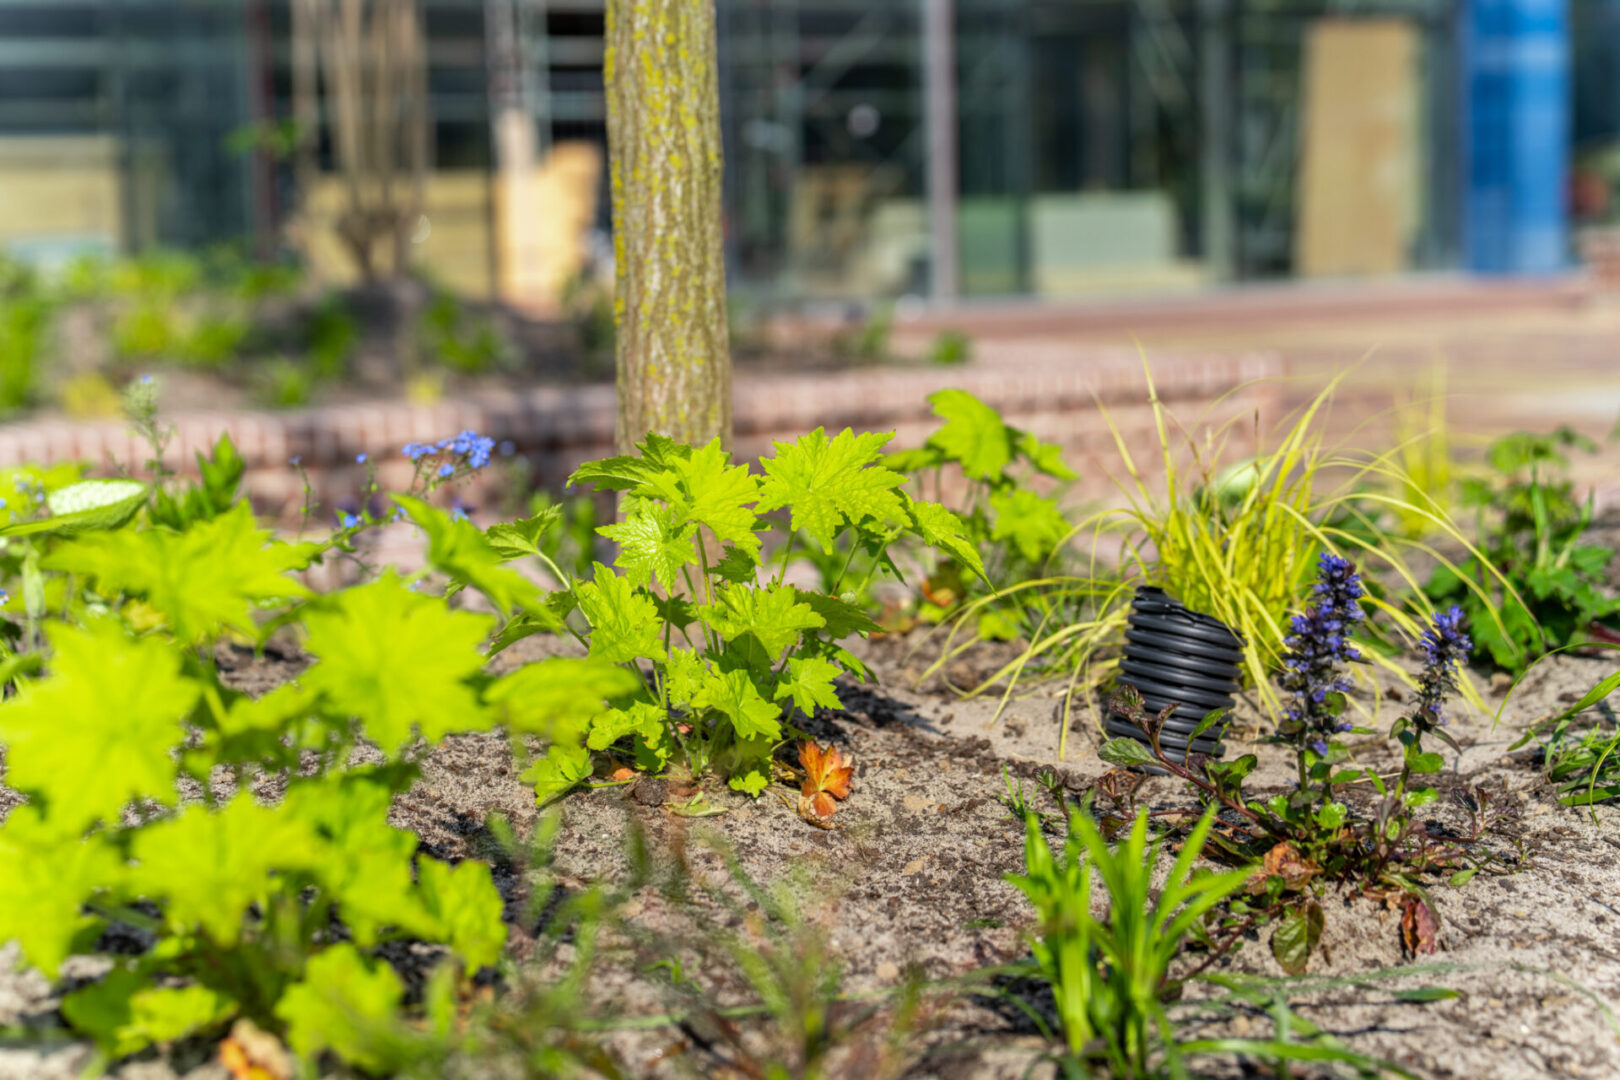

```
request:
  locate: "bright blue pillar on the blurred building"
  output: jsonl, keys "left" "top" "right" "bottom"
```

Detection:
{"left": 1463, "top": 0, "right": 1570, "bottom": 274}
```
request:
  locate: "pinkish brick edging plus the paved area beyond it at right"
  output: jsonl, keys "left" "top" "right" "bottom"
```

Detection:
{"left": 12, "top": 279, "right": 1620, "bottom": 517}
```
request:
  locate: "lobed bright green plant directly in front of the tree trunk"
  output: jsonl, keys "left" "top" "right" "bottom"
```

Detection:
{"left": 537, "top": 429, "right": 967, "bottom": 800}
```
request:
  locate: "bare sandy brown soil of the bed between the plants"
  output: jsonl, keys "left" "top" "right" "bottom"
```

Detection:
{"left": 9, "top": 621, "right": 1620, "bottom": 1080}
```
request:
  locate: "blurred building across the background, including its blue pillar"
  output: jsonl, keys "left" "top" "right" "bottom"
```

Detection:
{"left": 0, "top": 0, "right": 1594, "bottom": 311}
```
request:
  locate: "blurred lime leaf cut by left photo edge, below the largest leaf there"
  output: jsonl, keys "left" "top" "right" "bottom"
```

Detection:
{"left": 0, "top": 806, "right": 123, "bottom": 978}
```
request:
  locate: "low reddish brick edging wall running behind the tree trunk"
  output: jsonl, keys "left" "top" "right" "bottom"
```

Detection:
{"left": 0, "top": 342, "right": 1283, "bottom": 521}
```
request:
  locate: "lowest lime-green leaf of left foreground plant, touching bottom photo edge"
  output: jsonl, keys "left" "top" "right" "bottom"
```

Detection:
{"left": 275, "top": 944, "right": 405, "bottom": 1074}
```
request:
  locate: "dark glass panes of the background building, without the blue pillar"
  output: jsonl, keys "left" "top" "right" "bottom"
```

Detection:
{"left": 0, "top": 0, "right": 1581, "bottom": 303}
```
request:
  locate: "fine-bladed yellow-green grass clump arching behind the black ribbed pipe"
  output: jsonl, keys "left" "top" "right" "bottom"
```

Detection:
{"left": 928, "top": 366, "right": 1500, "bottom": 756}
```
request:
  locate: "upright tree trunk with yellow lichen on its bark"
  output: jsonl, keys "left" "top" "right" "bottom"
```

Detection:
{"left": 604, "top": 0, "right": 731, "bottom": 452}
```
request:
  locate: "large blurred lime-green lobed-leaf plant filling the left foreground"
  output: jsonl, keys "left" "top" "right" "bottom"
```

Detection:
{"left": 0, "top": 414, "right": 637, "bottom": 1074}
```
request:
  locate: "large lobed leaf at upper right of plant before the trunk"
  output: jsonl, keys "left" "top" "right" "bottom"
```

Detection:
{"left": 757, "top": 427, "right": 906, "bottom": 552}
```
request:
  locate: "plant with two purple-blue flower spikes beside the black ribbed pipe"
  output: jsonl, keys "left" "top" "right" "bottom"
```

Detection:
{"left": 1098, "top": 552, "right": 1523, "bottom": 973}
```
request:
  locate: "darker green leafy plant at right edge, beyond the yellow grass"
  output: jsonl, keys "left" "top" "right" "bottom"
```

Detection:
{"left": 1426, "top": 427, "right": 1620, "bottom": 675}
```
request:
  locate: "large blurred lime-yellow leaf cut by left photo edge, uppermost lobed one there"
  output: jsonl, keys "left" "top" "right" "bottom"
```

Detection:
{"left": 0, "top": 619, "right": 201, "bottom": 832}
